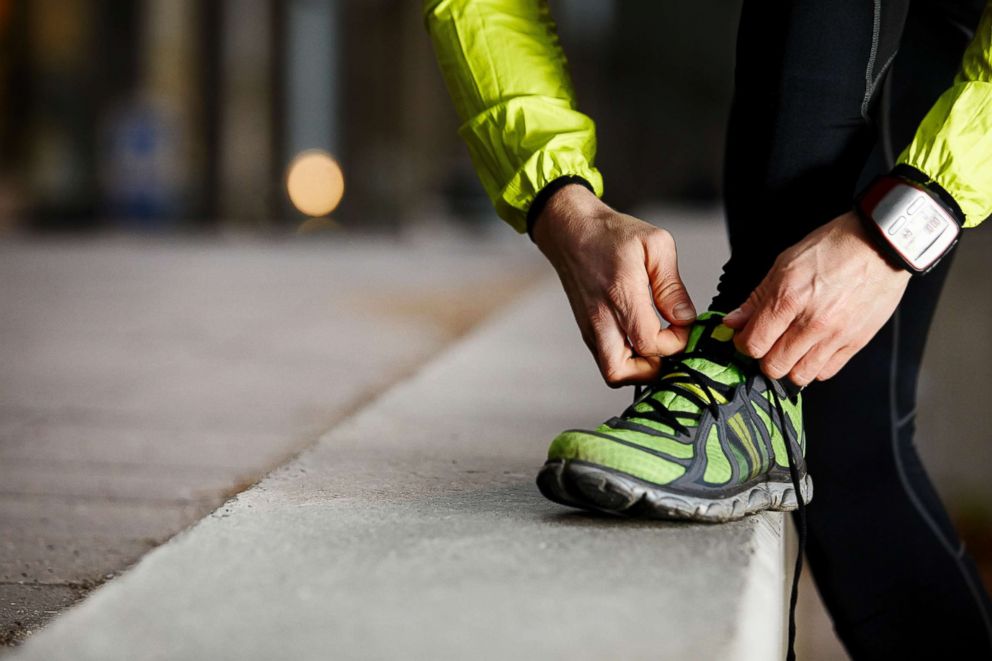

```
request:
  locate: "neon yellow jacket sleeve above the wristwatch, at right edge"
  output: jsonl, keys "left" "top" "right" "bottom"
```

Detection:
{"left": 897, "top": 1, "right": 992, "bottom": 227}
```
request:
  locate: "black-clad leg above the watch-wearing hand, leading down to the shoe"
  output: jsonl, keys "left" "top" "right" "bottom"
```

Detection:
{"left": 711, "top": 0, "right": 906, "bottom": 311}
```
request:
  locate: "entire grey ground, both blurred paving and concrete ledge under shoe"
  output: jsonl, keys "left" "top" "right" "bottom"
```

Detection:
{"left": 0, "top": 210, "right": 992, "bottom": 659}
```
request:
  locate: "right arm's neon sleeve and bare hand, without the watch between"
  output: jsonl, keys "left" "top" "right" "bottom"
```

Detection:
{"left": 725, "top": 2, "right": 992, "bottom": 385}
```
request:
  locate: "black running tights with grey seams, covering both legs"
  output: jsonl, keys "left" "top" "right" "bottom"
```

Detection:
{"left": 711, "top": 0, "right": 992, "bottom": 659}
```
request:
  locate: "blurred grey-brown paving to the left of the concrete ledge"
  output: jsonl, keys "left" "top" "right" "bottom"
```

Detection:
{"left": 0, "top": 236, "right": 543, "bottom": 643}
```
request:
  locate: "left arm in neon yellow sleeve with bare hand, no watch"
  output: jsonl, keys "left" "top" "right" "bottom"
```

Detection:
{"left": 425, "top": 0, "right": 696, "bottom": 386}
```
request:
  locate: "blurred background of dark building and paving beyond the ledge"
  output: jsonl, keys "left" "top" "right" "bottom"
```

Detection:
{"left": 0, "top": 0, "right": 992, "bottom": 658}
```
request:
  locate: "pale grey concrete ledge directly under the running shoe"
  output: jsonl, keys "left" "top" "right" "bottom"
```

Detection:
{"left": 7, "top": 282, "right": 786, "bottom": 661}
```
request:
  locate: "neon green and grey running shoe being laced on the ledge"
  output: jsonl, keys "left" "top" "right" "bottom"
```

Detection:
{"left": 537, "top": 312, "right": 813, "bottom": 521}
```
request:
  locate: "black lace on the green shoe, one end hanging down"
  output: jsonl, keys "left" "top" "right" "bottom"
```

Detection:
{"left": 623, "top": 360, "right": 806, "bottom": 661}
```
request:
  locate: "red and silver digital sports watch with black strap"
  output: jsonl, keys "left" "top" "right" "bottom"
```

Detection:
{"left": 854, "top": 174, "right": 961, "bottom": 273}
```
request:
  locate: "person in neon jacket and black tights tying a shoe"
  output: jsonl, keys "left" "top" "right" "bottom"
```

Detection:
{"left": 425, "top": 0, "right": 992, "bottom": 658}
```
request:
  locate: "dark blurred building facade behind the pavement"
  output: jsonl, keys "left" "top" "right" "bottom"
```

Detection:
{"left": 0, "top": 0, "right": 737, "bottom": 231}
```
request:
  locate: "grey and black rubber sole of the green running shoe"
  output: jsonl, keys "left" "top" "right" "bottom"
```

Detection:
{"left": 537, "top": 459, "right": 813, "bottom": 523}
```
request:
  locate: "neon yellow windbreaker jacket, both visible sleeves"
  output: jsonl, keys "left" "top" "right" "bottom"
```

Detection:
{"left": 424, "top": 0, "right": 992, "bottom": 232}
